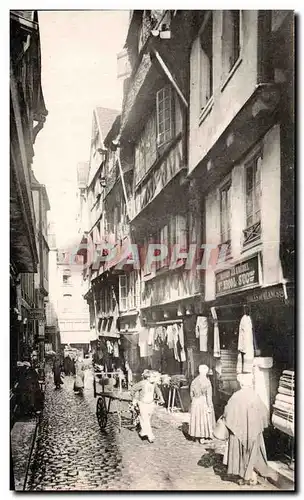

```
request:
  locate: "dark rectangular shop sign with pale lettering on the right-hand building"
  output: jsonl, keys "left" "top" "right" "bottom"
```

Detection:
{"left": 215, "top": 255, "right": 259, "bottom": 296}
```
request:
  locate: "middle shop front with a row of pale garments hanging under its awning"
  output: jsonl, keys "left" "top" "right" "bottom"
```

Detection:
{"left": 138, "top": 295, "right": 213, "bottom": 411}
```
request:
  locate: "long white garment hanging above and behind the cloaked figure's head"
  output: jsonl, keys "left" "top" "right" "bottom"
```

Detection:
{"left": 238, "top": 314, "right": 254, "bottom": 373}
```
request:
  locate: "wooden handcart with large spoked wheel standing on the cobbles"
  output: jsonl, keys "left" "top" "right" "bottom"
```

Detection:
{"left": 93, "top": 372, "right": 134, "bottom": 432}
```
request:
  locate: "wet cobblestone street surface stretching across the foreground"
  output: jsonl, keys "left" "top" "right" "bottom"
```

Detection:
{"left": 27, "top": 372, "right": 277, "bottom": 491}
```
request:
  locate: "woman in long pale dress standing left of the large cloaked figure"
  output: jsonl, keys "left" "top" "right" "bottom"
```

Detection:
{"left": 189, "top": 365, "right": 215, "bottom": 444}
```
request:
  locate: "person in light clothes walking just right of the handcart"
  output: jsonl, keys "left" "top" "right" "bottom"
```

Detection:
{"left": 131, "top": 370, "right": 164, "bottom": 443}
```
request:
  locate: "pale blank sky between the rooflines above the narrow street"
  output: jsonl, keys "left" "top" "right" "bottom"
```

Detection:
{"left": 33, "top": 10, "right": 129, "bottom": 246}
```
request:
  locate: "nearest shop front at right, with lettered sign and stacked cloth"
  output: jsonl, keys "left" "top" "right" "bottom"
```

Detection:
{"left": 206, "top": 254, "right": 294, "bottom": 460}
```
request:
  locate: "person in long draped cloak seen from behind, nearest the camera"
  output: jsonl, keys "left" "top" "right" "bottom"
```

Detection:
{"left": 224, "top": 374, "right": 271, "bottom": 484}
